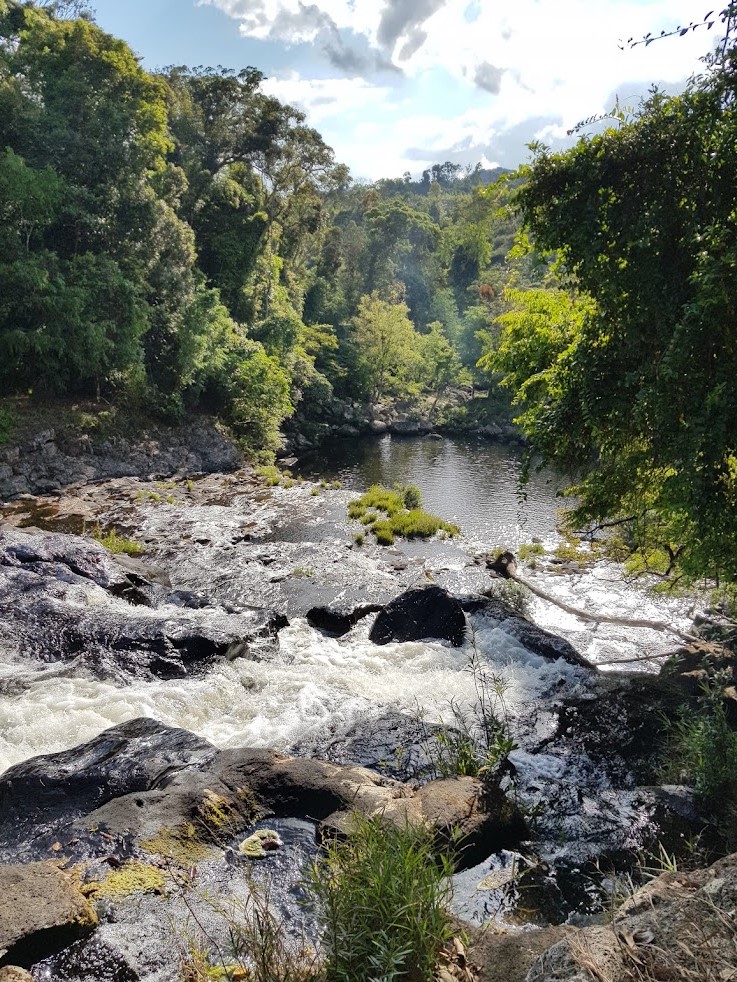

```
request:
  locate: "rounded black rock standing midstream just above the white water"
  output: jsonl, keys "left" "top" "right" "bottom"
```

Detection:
{"left": 369, "top": 586, "right": 466, "bottom": 647}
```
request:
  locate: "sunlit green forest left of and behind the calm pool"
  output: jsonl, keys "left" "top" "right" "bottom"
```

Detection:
{"left": 0, "top": 0, "right": 528, "bottom": 450}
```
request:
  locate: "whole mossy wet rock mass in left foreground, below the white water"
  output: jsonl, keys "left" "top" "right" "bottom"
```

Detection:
{"left": 0, "top": 720, "right": 525, "bottom": 982}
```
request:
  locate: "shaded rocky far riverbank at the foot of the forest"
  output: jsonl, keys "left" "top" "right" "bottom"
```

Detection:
{"left": 0, "top": 389, "right": 522, "bottom": 501}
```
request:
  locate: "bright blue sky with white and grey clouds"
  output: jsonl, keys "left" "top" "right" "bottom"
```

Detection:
{"left": 92, "top": 0, "right": 718, "bottom": 180}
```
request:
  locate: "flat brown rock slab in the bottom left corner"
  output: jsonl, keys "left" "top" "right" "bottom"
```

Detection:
{"left": 0, "top": 862, "right": 97, "bottom": 966}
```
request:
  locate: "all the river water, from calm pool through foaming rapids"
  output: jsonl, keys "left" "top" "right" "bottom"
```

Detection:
{"left": 0, "top": 437, "right": 700, "bottom": 920}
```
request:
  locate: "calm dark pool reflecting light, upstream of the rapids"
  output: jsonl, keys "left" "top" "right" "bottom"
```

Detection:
{"left": 301, "top": 435, "right": 565, "bottom": 547}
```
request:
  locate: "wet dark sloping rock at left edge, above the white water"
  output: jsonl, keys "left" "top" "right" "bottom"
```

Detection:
{"left": 0, "top": 529, "right": 285, "bottom": 680}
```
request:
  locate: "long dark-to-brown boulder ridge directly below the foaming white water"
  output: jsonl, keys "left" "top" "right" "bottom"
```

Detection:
{"left": 0, "top": 719, "right": 525, "bottom": 864}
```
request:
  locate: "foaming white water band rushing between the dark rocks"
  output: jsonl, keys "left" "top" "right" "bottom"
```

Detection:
{"left": 0, "top": 618, "right": 585, "bottom": 771}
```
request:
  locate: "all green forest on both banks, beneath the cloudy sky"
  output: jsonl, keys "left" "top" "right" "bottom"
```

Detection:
{"left": 0, "top": 0, "right": 737, "bottom": 580}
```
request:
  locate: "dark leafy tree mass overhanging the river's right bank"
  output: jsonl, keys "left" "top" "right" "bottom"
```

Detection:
{"left": 482, "top": 3, "right": 737, "bottom": 581}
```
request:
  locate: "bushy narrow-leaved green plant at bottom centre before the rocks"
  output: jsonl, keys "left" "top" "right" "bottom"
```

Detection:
{"left": 306, "top": 815, "right": 453, "bottom": 982}
